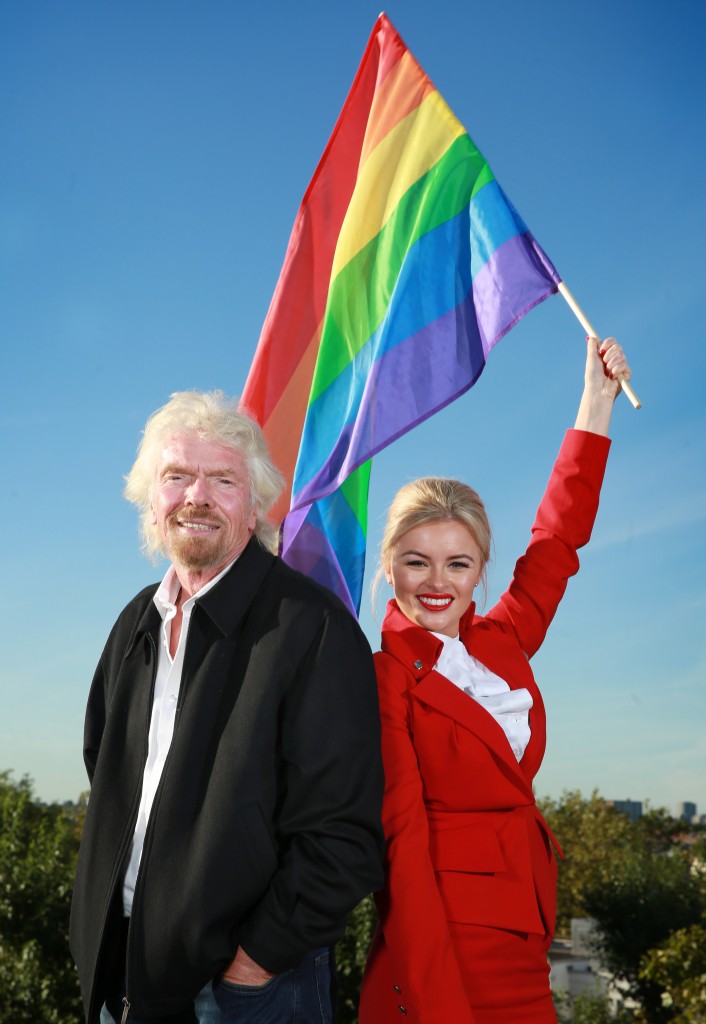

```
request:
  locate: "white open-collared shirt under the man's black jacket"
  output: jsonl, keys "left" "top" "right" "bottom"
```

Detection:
{"left": 123, "top": 559, "right": 235, "bottom": 918}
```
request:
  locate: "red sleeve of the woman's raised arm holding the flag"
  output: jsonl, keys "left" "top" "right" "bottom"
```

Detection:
{"left": 486, "top": 430, "right": 611, "bottom": 657}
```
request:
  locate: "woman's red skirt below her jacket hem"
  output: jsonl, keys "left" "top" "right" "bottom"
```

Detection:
{"left": 360, "top": 922, "right": 556, "bottom": 1024}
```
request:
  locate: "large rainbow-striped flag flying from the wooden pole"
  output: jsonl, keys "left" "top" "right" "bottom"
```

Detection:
{"left": 243, "top": 14, "right": 560, "bottom": 612}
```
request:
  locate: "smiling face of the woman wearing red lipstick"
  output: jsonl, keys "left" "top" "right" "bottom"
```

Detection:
{"left": 386, "top": 519, "right": 483, "bottom": 637}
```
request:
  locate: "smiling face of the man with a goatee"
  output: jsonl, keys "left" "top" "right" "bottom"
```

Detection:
{"left": 151, "top": 433, "right": 257, "bottom": 579}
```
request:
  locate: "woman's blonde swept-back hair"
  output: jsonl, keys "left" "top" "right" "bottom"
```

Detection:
{"left": 372, "top": 476, "right": 492, "bottom": 600}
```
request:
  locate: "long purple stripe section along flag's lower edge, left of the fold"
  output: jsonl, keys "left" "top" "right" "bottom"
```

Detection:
{"left": 290, "top": 286, "right": 485, "bottom": 515}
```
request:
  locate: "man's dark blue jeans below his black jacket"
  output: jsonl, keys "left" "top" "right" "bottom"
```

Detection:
{"left": 100, "top": 949, "right": 335, "bottom": 1024}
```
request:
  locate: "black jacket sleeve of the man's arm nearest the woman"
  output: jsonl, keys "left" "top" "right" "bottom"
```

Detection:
{"left": 239, "top": 609, "right": 383, "bottom": 972}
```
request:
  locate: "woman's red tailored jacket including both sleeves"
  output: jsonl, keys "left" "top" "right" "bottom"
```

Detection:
{"left": 361, "top": 430, "right": 610, "bottom": 1024}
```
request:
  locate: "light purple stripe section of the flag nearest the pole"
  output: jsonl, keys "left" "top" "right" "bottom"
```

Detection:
{"left": 473, "top": 231, "right": 562, "bottom": 355}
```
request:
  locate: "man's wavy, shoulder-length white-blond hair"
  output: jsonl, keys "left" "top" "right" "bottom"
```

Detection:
{"left": 123, "top": 391, "right": 284, "bottom": 559}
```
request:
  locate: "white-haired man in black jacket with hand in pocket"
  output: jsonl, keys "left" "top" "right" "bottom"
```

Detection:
{"left": 71, "top": 392, "right": 383, "bottom": 1024}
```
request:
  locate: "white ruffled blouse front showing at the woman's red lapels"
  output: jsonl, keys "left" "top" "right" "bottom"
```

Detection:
{"left": 433, "top": 633, "right": 532, "bottom": 761}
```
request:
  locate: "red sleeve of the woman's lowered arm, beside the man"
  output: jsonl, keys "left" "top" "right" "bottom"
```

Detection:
{"left": 375, "top": 653, "right": 473, "bottom": 1024}
